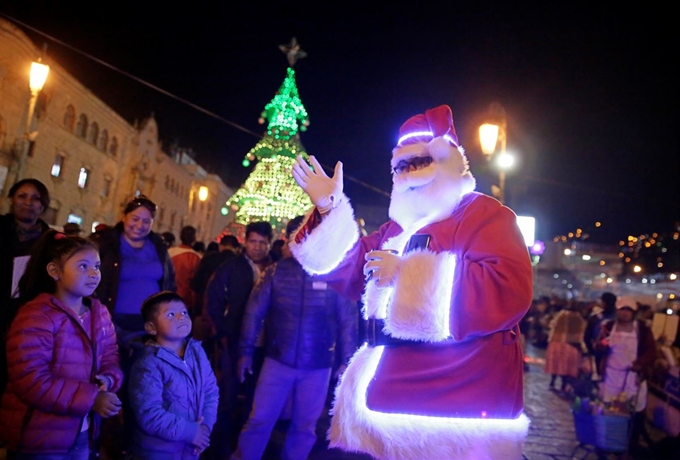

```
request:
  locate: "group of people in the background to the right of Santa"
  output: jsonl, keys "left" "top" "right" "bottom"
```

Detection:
{"left": 522, "top": 292, "right": 659, "bottom": 401}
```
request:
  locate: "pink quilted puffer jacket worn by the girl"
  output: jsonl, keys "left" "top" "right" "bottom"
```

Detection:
{"left": 0, "top": 294, "right": 123, "bottom": 453}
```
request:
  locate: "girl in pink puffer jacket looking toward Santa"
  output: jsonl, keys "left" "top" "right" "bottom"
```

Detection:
{"left": 0, "top": 230, "right": 123, "bottom": 460}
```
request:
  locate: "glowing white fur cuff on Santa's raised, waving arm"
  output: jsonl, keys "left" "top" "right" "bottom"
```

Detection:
{"left": 290, "top": 196, "right": 359, "bottom": 275}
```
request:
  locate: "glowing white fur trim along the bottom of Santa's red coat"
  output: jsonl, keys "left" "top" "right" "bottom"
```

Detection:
{"left": 328, "top": 345, "right": 530, "bottom": 460}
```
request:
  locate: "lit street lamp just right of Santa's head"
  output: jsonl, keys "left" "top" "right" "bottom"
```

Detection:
{"left": 479, "top": 102, "right": 514, "bottom": 204}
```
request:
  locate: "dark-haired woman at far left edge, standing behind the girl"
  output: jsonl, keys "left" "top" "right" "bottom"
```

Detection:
{"left": 0, "top": 179, "right": 50, "bottom": 394}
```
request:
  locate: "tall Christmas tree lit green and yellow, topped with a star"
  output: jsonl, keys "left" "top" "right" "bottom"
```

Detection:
{"left": 226, "top": 38, "right": 312, "bottom": 231}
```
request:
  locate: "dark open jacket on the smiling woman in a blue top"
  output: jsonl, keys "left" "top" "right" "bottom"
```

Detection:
{"left": 95, "top": 222, "right": 177, "bottom": 314}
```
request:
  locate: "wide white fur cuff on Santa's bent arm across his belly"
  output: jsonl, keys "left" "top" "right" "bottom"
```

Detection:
{"left": 385, "top": 251, "right": 456, "bottom": 342}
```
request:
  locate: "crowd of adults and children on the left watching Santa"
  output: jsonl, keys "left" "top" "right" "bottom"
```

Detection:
{"left": 0, "top": 179, "right": 359, "bottom": 459}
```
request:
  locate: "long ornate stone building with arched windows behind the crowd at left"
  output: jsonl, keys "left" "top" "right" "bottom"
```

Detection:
{"left": 0, "top": 18, "right": 232, "bottom": 242}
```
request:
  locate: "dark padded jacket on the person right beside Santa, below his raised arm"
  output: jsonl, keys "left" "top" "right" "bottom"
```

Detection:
{"left": 239, "top": 257, "right": 358, "bottom": 369}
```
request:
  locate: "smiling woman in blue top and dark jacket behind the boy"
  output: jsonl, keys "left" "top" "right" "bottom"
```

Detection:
{"left": 96, "top": 195, "right": 176, "bottom": 457}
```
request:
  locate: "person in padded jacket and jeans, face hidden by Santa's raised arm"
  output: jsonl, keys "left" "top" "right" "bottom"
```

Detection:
{"left": 232, "top": 216, "right": 358, "bottom": 460}
